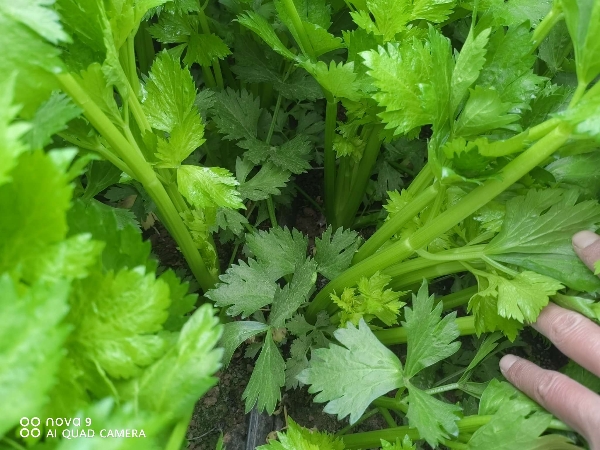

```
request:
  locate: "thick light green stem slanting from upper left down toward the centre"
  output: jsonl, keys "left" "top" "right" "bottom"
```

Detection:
{"left": 57, "top": 73, "right": 217, "bottom": 291}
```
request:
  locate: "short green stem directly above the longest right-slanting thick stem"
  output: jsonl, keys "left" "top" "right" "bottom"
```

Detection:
{"left": 352, "top": 184, "right": 439, "bottom": 264}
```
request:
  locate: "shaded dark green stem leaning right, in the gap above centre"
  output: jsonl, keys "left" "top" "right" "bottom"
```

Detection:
{"left": 336, "top": 125, "right": 383, "bottom": 228}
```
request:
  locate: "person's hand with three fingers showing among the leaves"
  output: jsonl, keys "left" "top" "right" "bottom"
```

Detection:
{"left": 500, "top": 231, "right": 600, "bottom": 450}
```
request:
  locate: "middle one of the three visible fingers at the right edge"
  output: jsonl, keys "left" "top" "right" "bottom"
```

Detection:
{"left": 532, "top": 303, "right": 600, "bottom": 376}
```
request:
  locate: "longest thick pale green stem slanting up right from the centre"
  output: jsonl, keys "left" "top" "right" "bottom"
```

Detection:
{"left": 306, "top": 124, "right": 571, "bottom": 323}
